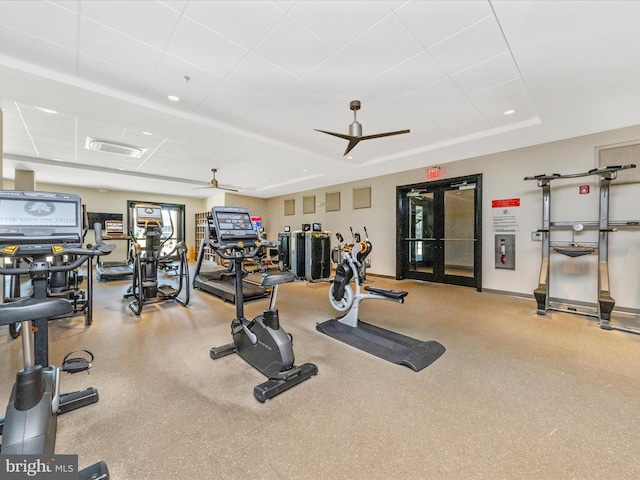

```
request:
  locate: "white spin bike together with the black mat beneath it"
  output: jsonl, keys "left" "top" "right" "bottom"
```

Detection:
{"left": 316, "top": 228, "right": 445, "bottom": 372}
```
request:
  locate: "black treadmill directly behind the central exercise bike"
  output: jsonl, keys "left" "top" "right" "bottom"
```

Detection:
{"left": 193, "top": 216, "right": 271, "bottom": 304}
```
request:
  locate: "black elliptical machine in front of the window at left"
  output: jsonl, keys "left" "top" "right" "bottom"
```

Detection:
{"left": 124, "top": 203, "right": 190, "bottom": 315}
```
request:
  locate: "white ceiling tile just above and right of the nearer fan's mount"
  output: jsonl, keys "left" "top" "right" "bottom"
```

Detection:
{"left": 376, "top": 52, "right": 447, "bottom": 96}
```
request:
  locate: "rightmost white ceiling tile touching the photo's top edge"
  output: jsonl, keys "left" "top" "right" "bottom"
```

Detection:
{"left": 394, "top": 0, "right": 493, "bottom": 49}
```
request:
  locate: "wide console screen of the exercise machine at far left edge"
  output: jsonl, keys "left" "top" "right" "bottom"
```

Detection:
{"left": 0, "top": 190, "right": 82, "bottom": 254}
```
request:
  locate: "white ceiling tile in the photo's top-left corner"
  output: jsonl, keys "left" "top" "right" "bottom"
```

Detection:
{"left": 0, "top": 0, "right": 78, "bottom": 49}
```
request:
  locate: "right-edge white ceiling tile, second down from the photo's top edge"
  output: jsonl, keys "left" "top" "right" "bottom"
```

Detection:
{"left": 429, "top": 16, "right": 509, "bottom": 75}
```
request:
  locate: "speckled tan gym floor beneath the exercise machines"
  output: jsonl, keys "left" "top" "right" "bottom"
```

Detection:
{"left": 0, "top": 268, "right": 640, "bottom": 480}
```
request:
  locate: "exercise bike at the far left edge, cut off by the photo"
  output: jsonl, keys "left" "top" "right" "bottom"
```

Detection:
{"left": 0, "top": 191, "right": 113, "bottom": 479}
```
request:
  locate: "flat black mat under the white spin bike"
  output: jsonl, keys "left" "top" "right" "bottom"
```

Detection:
{"left": 316, "top": 319, "right": 445, "bottom": 372}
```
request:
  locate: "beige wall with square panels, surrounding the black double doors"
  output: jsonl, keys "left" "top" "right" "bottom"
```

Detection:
{"left": 266, "top": 126, "right": 640, "bottom": 309}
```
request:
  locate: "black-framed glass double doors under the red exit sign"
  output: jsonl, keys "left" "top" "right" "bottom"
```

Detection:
{"left": 396, "top": 175, "right": 482, "bottom": 291}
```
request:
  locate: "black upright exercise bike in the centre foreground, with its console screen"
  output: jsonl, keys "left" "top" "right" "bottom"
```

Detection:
{"left": 209, "top": 207, "right": 318, "bottom": 403}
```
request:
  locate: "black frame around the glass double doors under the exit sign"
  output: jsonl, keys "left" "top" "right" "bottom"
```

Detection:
{"left": 396, "top": 173, "right": 482, "bottom": 292}
